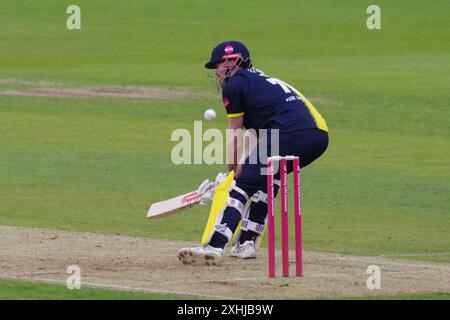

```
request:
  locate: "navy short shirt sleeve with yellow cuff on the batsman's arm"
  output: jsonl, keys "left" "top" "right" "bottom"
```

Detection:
{"left": 222, "top": 76, "right": 245, "bottom": 118}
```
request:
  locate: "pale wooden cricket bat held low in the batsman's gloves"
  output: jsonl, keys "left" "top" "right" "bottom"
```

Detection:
{"left": 147, "top": 191, "right": 202, "bottom": 219}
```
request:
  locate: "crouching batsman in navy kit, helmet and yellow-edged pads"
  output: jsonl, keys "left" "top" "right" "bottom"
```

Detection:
{"left": 178, "top": 41, "right": 328, "bottom": 265}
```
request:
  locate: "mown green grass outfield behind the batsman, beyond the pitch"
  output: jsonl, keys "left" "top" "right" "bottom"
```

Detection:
{"left": 0, "top": 0, "right": 450, "bottom": 298}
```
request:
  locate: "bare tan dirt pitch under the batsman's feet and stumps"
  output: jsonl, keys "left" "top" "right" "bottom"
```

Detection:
{"left": 0, "top": 226, "right": 450, "bottom": 299}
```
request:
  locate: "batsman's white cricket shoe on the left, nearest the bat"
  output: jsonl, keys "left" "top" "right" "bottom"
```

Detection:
{"left": 177, "top": 245, "right": 223, "bottom": 266}
